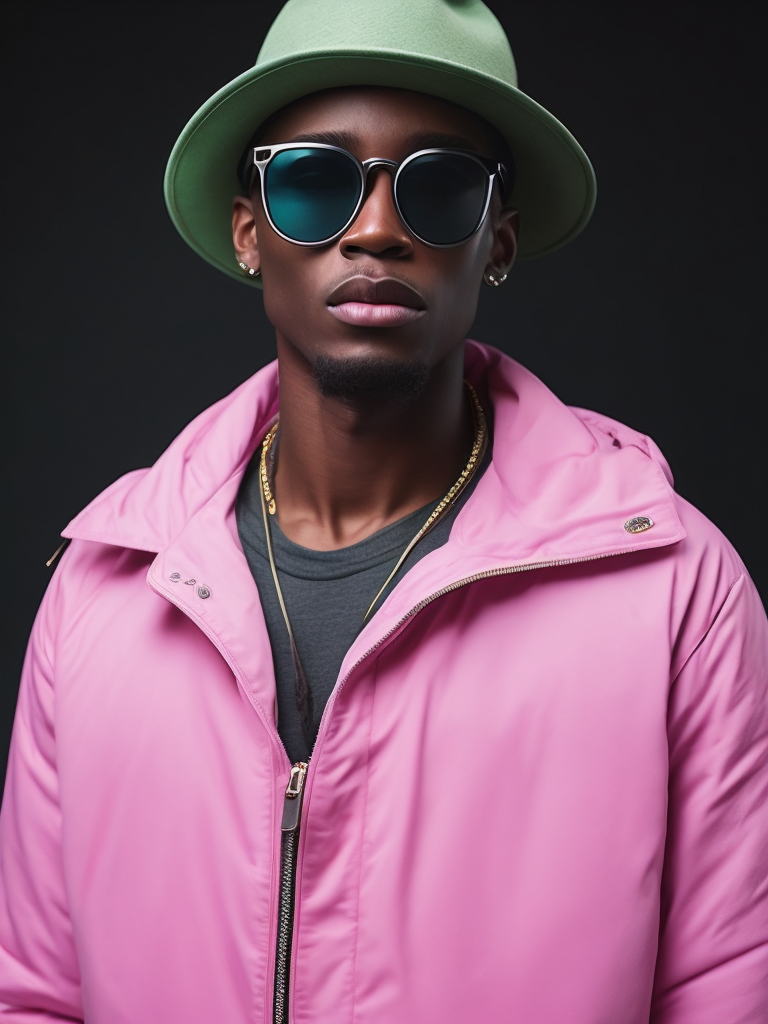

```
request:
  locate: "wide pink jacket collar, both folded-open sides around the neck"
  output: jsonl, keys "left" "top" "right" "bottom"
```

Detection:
{"left": 62, "top": 342, "right": 685, "bottom": 571}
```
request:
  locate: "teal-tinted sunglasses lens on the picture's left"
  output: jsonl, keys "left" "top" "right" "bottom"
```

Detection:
{"left": 264, "top": 148, "right": 361, "bottom": 242}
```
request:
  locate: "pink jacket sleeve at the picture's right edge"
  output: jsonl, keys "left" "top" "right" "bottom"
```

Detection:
{"left": 650, "top": 575, "right": 768, "bottom": 1024}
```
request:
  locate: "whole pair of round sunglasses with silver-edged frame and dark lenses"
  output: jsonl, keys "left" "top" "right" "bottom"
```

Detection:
{"left": 243, "top": 142, "right": 508, "bottom": 249}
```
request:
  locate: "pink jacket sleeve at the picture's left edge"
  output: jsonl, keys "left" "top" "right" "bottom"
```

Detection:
{"left": 0, "top": 567, "right": 83, "bottom": 1024}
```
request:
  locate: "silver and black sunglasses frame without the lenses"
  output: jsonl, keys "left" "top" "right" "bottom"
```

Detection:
{"left": 245, "top": 142, "right": 508, "bottom": 249}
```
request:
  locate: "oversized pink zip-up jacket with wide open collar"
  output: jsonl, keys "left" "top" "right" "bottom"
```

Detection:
{"left": 0, "top": 343, "right": 768, "bottom": 1024}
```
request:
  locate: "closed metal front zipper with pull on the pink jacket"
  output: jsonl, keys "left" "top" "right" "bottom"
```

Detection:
{"left": 273, "top": 761, "right": 307, "bottom": 1024}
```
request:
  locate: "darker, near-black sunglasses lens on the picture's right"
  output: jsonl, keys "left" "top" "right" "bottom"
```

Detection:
{"left": 397, "top": 153, "right": 488, "bottom": 246}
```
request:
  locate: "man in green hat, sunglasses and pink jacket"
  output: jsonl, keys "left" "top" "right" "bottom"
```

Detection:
{"left": 0, "top": 0, "right": 768, "bottom": 1024}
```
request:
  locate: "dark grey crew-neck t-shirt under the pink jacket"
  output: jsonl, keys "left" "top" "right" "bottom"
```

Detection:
{"left": 236, "top": 445, "right": 490, "bottom": 763}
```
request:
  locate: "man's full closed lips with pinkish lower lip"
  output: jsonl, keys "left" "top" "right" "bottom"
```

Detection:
{"left": 326, "top": 276, "right": 426, "bottom": 327}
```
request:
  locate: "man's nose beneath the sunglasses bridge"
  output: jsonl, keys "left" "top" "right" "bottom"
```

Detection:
{"left": 339, "top": 167, "right": 414, "bottom": 259}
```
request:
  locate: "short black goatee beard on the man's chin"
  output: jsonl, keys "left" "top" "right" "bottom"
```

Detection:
{"left": 312, "top": 355, "right": 429, "bottom": 406}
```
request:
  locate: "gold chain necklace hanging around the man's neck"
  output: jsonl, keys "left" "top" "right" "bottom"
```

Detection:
{"left": 259, "top": 380, "right": 488, "bottom": 643}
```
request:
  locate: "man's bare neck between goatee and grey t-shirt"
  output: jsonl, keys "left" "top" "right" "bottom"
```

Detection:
{"left": 274, "top": 341, "right": 473, "bottom": 551}
